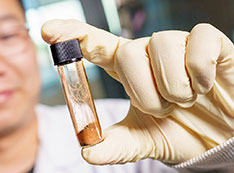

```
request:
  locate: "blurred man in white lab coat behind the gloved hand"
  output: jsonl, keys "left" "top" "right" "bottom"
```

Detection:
{"left": 0, "top": 0, "right": 177, "bottom": 173}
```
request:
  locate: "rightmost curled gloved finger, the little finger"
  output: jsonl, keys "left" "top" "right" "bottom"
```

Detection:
{"left": 186, "top": 24, "right": 233, "bottom": 94}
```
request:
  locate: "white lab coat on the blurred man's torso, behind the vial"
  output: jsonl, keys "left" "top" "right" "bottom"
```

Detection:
{"left": 34, "top": 99, "right": 175, "bottom": 173}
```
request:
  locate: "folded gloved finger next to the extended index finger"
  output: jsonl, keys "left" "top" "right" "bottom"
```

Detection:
{"left": 114, "top": 38, "right": 173, "bottom": 118}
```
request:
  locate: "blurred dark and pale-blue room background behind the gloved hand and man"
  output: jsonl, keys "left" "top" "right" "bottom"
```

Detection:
{"left": 23, "top": 0, "right": 234, "bottom": 105}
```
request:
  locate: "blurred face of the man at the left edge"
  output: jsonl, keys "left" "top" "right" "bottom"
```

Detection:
{"left": 0, "top": 0, "right": 40, "bottom": 136}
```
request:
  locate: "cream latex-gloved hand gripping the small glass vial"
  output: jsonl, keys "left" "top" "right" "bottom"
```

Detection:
{"left": 42, "top": 20, "right": 234, "bottom": 164}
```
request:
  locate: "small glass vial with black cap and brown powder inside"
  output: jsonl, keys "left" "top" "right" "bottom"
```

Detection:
{"left": 51, "top": 39, "right": 102, "bottom": 146}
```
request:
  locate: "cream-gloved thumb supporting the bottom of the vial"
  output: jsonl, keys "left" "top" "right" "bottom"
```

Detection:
{"left": 82, "top": 107, "right": 155, "bottom": 165}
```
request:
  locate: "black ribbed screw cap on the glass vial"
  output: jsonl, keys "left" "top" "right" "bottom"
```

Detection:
{"left": 50, "top": 39, "right": 83, "bottom": 65}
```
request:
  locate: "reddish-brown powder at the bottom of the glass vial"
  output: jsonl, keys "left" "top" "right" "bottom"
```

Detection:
{"left": 77, "top": 122, "right": 102, "bottom": 146}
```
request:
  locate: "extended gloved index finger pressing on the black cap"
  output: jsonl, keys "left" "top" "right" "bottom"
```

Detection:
{"left": 41, "top": 20, "right": 128, "bottom": 71}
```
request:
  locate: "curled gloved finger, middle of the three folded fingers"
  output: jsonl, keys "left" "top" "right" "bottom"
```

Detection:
{"left": 148, "top": 31, "right": 197, "bottom": 107}
